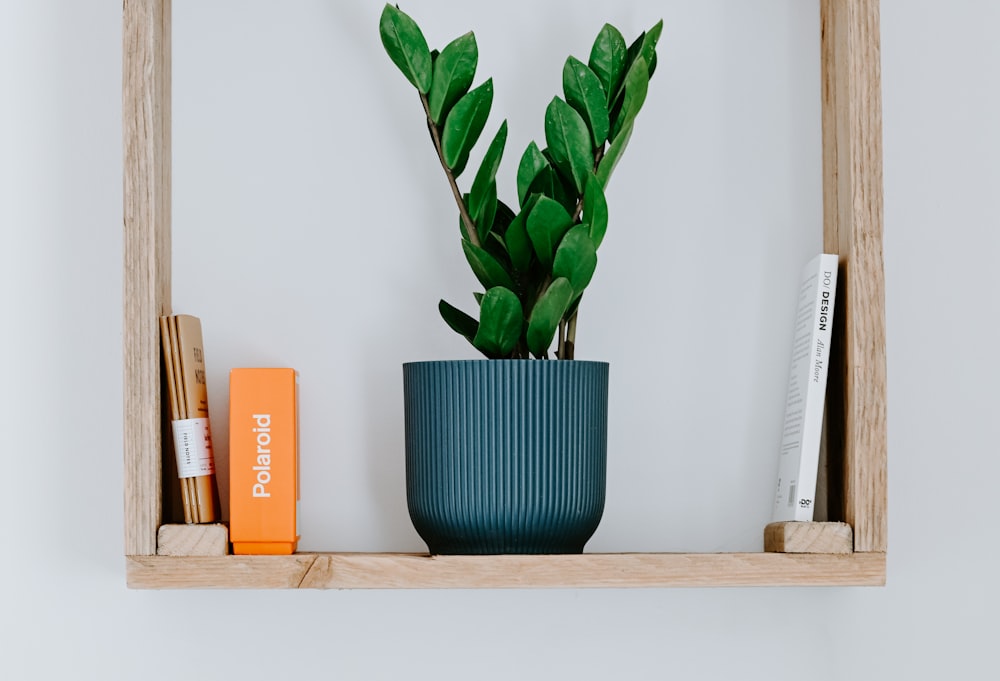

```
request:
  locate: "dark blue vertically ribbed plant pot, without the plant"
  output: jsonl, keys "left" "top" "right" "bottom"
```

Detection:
{"left": 403, "top": 360, "right": 608, "bottom": 554}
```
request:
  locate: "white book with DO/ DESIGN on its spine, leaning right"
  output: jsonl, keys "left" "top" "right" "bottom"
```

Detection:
{"left": 772, "top": 253, "right": 838, "bottom": 522}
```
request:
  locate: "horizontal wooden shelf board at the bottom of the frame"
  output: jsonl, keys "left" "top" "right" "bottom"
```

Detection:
{"left": 126, "top": 553, "right": 885, "bottom": 589}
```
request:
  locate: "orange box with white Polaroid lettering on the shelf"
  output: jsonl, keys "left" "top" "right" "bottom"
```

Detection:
{"left": 229, "top": 369, "right": 299, "bottom": 554}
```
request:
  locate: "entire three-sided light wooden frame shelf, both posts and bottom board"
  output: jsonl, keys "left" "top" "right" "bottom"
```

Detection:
{"left": 122, "top": 0, "right": 887, "bottom": 588}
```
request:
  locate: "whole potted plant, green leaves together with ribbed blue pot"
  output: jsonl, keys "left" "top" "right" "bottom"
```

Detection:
{"left": 379, "top": 4, "right": 663, "bottom": 554}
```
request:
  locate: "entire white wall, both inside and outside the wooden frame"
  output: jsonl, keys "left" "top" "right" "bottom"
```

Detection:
{"left": 0, "top": 0, "right": 1000, "bottom": 679}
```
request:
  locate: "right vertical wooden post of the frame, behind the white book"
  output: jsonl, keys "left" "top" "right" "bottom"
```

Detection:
{"left": 820, "top": 0, "right": 887, "bottom": 552}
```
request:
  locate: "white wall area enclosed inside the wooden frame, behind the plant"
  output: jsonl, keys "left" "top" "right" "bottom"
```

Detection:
{"left": 173, "top": 0, "right": 822, "bottom": 551}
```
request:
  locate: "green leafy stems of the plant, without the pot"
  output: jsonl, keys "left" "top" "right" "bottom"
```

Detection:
{"left": 379, "top": 4, "right": 663, "bottom": 359}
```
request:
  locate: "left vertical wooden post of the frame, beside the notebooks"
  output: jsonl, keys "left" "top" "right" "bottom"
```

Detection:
{"left": 122, "top": 0, "right": 170, "bottom": 555}
